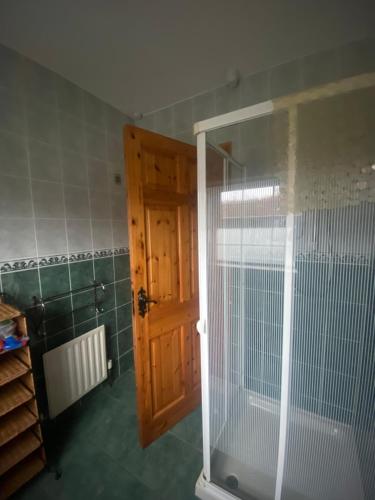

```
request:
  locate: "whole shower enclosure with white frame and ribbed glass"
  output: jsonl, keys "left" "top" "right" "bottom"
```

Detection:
{"left": 195, "top": 74, "right": 375, "bottom": 500}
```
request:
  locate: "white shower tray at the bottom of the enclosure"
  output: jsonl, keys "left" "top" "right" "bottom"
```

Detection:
{"left": 196, "top": 390, "right": 364, "bottom": 500}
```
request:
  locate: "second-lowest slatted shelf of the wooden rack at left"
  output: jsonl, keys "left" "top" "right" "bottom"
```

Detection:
{"left": 0, "top": 430, "right": 41, "bottom": 475}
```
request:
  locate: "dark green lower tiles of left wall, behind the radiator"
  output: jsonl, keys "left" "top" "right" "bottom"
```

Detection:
{"left": 2, "top": 250, "right": 133, "bottom": 415}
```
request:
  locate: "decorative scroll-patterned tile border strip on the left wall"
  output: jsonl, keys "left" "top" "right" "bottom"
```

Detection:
{"left": 0, "top": 247, "right": 129, "bottom": 274}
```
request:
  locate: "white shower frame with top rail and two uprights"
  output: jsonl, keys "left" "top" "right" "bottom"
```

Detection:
{"left": 194, "top": 73, "right": 375, "bottom": 500}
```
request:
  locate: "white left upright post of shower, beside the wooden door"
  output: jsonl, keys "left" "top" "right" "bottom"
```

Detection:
{"left": 197, "top": 132, "right": 211, "bottom": 481}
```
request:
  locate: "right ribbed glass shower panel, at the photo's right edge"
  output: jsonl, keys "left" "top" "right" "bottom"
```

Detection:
{"left": 282, "top": 89, "right": 375, "bottom": 500}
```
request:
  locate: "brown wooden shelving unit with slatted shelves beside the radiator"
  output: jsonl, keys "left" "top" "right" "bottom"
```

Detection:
{"left": 0, "top": 303, "right": 46, "bottom": 500}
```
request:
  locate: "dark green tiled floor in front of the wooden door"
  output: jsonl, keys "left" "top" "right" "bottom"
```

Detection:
{"left": 16, "top": 371, "right": 202, "bottom": 500}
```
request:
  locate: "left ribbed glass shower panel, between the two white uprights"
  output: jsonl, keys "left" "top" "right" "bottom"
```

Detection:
{"left": 207, "top": 111, "right": 286, "bottom": 499}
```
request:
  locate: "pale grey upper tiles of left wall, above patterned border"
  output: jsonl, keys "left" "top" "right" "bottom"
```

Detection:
{"left": 0, "top": 46, "right": 130, "bottom": 262}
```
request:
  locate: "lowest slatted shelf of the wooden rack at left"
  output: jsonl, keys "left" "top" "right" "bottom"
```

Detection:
{"left": 0, "top": 452, "right": 45, "bottom": 500}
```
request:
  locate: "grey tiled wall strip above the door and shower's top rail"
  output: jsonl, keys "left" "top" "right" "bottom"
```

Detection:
{"left": 137, "top": 38, "right": 375, "bottom": 150}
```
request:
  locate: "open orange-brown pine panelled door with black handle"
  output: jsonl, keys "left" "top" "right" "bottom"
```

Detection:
{"left": 125, "top": 126, "right": 201, "bottom": 446}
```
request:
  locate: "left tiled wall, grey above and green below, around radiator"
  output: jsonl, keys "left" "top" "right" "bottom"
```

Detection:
{"left": 0, "top": 46, "right": 132, "bottom": 418}
